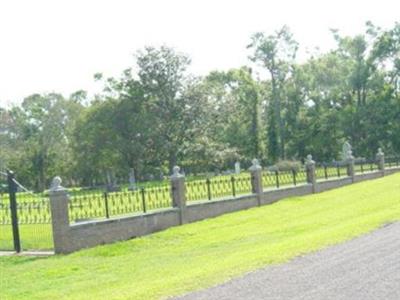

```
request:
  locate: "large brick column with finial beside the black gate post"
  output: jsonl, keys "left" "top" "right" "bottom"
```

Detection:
{"left": 50, "top": 177, "right": 70, "bottom": 253}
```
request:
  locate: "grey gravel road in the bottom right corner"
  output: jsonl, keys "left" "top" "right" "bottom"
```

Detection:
{"left": 176, "top": 223, "right": 400, "bottom": 300}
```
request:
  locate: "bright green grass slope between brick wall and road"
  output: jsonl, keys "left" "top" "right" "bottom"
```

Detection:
{"left": 0, "top": 174, "right": 400, "bottom": 299}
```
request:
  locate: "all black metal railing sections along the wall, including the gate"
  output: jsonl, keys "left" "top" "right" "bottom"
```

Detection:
{"left": 0, "top": 150, "right": 400, "bottom": 253}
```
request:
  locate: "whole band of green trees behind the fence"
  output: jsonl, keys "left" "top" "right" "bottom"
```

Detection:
{"left": 0, "top": 23, "right": 400, "bottom": 190}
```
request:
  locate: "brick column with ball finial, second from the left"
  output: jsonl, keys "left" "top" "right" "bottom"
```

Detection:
{"left": 171, "top": 166, "right": 186, "bottom": 224}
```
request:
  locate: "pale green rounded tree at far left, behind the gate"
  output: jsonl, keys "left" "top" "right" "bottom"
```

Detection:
{"left": 6, "top": 93, "right": 81, "bottom": 191}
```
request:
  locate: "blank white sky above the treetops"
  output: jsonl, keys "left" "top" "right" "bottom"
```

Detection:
{"left": 0, "top": 0, "right": 400, "bottom": 106}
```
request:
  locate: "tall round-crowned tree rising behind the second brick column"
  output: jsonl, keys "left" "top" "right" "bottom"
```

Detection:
{"left": 137, "top": 47, "right": 201, "bottom": 171}
